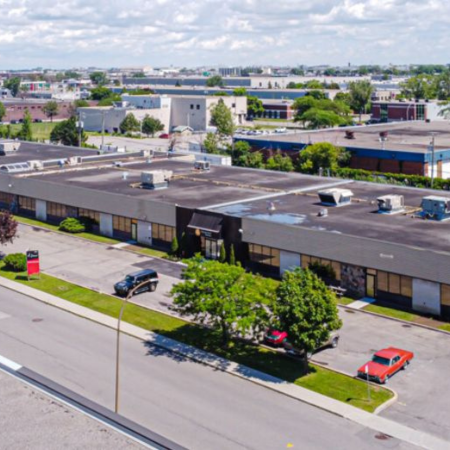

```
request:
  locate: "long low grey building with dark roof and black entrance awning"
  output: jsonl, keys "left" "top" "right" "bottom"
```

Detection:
{"left": 0, "top": 142, "right": 450, "bottom": 317}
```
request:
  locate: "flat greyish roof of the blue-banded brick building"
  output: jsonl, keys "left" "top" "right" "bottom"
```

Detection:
{"left": 243, "top": 120, "right": 450, "bottom": 153}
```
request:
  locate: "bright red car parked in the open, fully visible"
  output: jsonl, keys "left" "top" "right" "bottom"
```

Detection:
{"left": 358, "top": 347, "right": 414, "bottom": 384}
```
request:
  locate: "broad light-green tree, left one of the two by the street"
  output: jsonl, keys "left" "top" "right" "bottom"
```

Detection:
{"left": 171, "top": 256, "right": 274, "bottom": 345}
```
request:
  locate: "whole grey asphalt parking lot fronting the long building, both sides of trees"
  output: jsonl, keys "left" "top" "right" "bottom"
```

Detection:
{"left": 5, "top": 225, "right": 450, "bottom": 440}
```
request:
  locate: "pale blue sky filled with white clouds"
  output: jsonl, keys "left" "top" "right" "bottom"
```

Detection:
{"left": 0, "top": 0, "right": 450, "bottom": 69}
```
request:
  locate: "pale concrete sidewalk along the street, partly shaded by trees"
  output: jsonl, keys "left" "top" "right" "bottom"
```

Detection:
{"left": 0, "top": 277, "right": 450, "bottom": 450}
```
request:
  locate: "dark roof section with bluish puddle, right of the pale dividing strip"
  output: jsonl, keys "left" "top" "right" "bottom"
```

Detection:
{"left": 214, "top": 179, "right": 450, "bottom": 252}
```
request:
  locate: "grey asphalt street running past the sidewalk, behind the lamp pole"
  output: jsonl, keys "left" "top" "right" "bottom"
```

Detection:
{"left": 0, "top": 288, "right": 409, "bottom": 450}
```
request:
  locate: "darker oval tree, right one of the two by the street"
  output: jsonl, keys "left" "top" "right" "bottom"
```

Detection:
{"left": 275, "top": 268, "right": 342, "bottom": 354}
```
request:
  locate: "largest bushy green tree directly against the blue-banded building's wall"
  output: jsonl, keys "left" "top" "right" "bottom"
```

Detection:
{"left": 297, "top": 142, "right": 348, "bottom": 174}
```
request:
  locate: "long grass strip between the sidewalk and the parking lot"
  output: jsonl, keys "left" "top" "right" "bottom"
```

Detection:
{"left": 0, "top": 263, "right": 393, "bottom": 412}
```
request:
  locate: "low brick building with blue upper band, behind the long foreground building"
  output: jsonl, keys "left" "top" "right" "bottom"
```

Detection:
{"left": 235, "top": 121, "right": 450, "bottom": 178}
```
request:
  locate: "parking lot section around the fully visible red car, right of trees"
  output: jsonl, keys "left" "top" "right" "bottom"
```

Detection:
{"left": 313, "top": 309, "right": 450, "bottom": 439}
